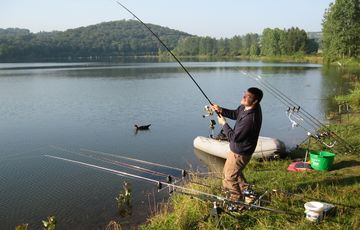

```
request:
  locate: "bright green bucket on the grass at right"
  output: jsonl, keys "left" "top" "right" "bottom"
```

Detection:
{"left": 310, "top": 151, "right": 335, "bottom": 171}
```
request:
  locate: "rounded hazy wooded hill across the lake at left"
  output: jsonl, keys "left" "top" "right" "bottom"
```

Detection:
{"left": 0, "top": 20, "right": 192, "bottom": 61}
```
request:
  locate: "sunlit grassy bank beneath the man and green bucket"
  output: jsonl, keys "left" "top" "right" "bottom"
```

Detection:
{"left": 140, "top": 86, "right": 360, "bottom": 229}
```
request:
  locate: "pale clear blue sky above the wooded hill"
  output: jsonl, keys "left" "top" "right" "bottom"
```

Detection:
{"left": 0, "top": 0, "right": 335, "bottom": 38}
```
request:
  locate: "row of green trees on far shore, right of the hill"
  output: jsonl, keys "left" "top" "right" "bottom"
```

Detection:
{"left": 175, "top": 27, "right": 319, "bottom": 56}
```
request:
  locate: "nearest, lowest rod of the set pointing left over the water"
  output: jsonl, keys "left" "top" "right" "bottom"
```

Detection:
{"left": 44, "top": 154, "right": 291, "bottom": 214}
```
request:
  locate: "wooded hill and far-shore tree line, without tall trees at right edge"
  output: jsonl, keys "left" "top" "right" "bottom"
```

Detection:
{"left": 0, "top": 20, "right": 318, "bottom": 61}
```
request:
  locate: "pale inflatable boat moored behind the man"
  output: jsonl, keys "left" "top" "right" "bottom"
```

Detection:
{"left": 194, "top": 136, "right": 286, "bottom": 159}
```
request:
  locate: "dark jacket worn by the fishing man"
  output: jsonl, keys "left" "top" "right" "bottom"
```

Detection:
{"left": 221, "top": 104, "right": 262, "bottom": 155}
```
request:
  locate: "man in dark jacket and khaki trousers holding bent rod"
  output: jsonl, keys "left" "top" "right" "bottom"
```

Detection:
{"left": 212, "top": 87, "right": 263, "bottom": 204}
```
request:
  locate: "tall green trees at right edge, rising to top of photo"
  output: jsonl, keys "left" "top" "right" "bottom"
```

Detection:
{"left": 322, "top": 0, "right": 360, "bottom": 61}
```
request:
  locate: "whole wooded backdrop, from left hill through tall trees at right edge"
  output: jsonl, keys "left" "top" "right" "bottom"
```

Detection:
{"left": 0, "top": 0, "right": 360, "bottom": 62}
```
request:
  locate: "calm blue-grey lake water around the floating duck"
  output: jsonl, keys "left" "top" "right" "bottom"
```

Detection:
{"left": 0, "top": 62, "right": 348, "bottom": 229}
